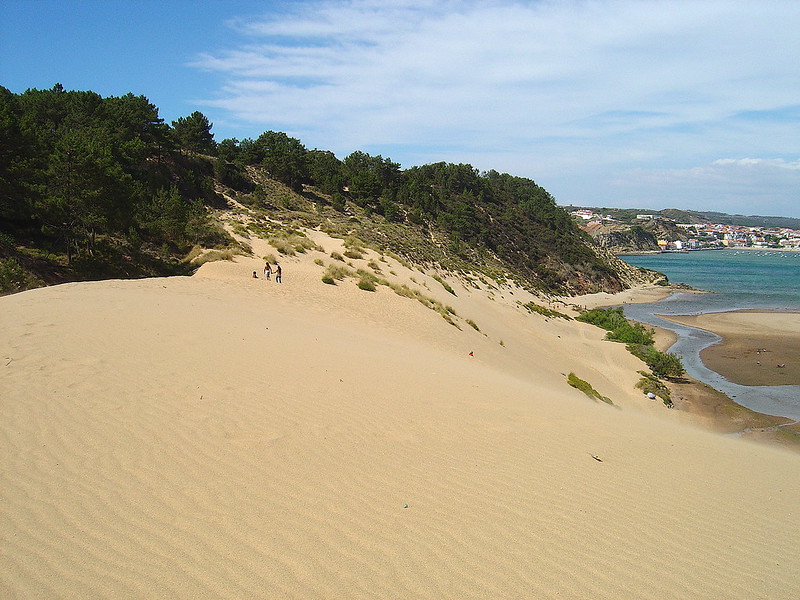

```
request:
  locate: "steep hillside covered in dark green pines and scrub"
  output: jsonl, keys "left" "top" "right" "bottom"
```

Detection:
{"left": 0, "top": 85, "right": 648, "bottom": 294}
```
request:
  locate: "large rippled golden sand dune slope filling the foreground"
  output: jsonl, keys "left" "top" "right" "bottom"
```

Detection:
{"left": 0, "top": 232, "right": 800, "bottom": 599}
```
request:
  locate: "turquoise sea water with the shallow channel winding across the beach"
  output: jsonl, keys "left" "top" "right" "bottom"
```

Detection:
{"left": 620, "top": 249, "right": 800, "bottom": 420}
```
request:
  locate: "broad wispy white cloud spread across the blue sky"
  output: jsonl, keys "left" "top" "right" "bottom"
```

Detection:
{"left": 193, "top": 0, "right": 800, "bottom": 216}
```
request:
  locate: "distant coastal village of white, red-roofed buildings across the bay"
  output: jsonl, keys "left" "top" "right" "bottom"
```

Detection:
{"left": 570, "top": 209, "right": 800, "bottom": 252}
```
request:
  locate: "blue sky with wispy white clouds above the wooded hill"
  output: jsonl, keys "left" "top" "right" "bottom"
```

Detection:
{"left": 0, "top": 0, "right": 800, "bottom": 217}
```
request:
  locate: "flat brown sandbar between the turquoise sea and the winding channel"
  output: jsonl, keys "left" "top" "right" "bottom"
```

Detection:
{"left": 660, "top": 310, "right": 800, "bottom": 385}
